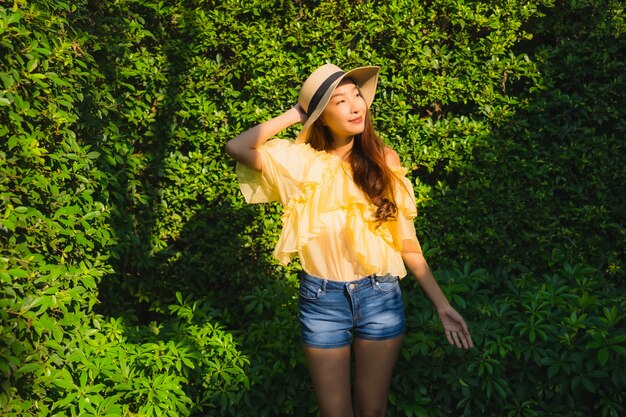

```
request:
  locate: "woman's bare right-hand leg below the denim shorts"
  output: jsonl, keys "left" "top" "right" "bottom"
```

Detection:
{"left": 354, "top": 336, "right": 403, "bottom": 417}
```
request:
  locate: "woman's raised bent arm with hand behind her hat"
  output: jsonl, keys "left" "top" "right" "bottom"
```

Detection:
{"left": 224, "top": 104, "right": 306, "bottom": 171}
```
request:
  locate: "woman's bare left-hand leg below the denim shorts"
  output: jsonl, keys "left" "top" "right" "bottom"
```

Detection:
{"left": 304, "top": 346, "right": 353, "bottom": 417}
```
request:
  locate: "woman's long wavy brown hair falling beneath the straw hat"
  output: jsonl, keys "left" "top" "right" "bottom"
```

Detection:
{"left": 307, "top": 109, "right": 398, "bottom": 224}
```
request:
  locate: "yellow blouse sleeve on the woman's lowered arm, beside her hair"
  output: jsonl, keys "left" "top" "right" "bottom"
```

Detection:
{"left": 391, "top": 165, "right": 422, "bottom": 253}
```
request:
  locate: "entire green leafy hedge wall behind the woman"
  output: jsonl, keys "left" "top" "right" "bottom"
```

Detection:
{"left": 0, "top": 0, "right": 626, "bottom": 416}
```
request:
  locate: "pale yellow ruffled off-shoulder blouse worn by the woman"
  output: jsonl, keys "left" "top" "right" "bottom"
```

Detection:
{"left": 237, "top": 139, "right": 421, "bottom": 281}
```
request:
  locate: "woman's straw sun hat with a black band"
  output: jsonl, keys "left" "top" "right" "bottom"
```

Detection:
{"left": 296, "top": 64, "right": 380, "bottom": 142}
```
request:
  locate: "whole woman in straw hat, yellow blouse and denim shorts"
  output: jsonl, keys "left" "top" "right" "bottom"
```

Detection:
{"left": 226, "top": 64, "right": 473, "bottom": 417}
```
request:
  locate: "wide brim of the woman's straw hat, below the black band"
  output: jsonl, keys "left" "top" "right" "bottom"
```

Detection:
{"left": 296, "top": 66, "right": 380, "bottom": 143}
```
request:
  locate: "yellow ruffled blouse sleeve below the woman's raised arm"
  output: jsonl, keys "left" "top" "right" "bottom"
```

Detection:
{"left": 236, "top": 139, "right": 321, "bottom": 204}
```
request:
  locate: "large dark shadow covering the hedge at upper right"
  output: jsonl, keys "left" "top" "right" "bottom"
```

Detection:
{"left": 418, "top": 1, "right": 626, "bottom": 277}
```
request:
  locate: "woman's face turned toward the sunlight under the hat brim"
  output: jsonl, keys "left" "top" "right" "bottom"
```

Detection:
{"left": 320, "top": 79, "right": 367, "bottom": 141}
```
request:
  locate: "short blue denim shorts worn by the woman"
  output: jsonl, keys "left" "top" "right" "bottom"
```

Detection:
{"left": 299, "top": 273, "right": 404, "bottom": 349}
